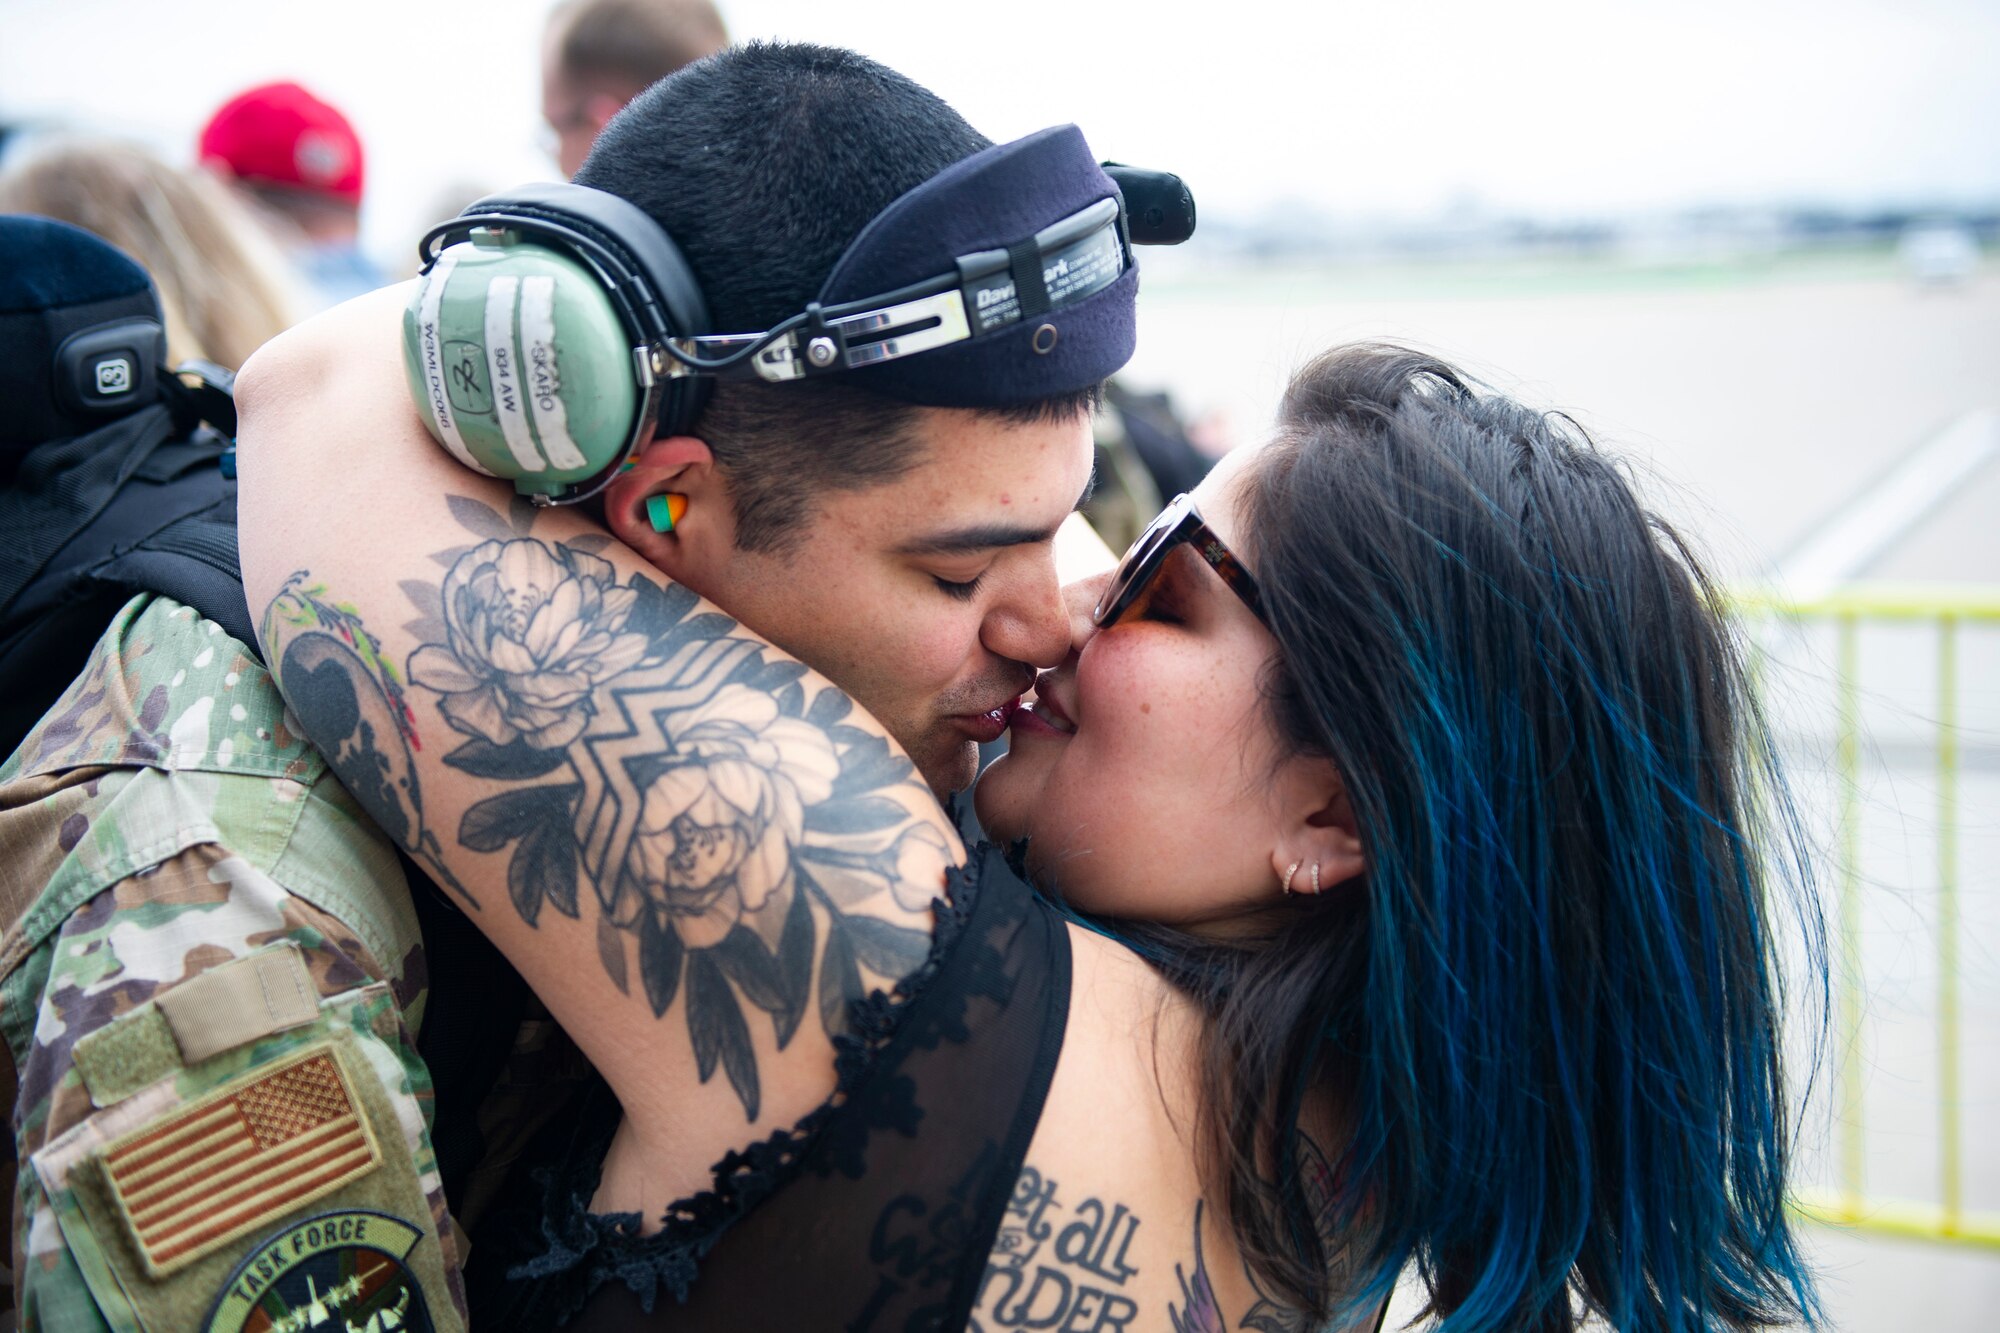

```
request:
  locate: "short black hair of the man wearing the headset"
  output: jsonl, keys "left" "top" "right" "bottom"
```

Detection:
{"left": 576, "top": 42, "right": 1100, "bottom": 552}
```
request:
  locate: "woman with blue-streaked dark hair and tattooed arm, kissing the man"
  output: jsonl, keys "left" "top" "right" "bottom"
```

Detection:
{"left": 242, "top": 324, "right": 1824, "bottom": 1333}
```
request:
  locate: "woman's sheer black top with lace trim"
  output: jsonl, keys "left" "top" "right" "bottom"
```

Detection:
{"left": 468, "top": 845, "right": 1070, "bottom": 1333}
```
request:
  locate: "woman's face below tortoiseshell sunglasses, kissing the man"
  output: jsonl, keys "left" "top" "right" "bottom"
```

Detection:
{"left": 974, "top": 440, "right": 1328, "bottom": 927}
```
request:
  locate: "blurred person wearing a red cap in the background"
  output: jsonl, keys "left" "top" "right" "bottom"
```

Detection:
{"left": 200, "top": 84, "right": 388, "bottom": 304}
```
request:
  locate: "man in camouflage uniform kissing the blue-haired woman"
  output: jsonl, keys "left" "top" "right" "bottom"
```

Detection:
{"left": 0, "top": 46, "right": 1132, "bottom": 1329}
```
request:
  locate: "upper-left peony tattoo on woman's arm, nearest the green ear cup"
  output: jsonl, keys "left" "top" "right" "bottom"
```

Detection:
{"left": 410, "top": 540, "right": 646, "bottom": 751}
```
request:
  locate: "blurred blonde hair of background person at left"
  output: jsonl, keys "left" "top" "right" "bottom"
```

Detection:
{"left": 0, "top": 140, "right": 296, "bottom": 370}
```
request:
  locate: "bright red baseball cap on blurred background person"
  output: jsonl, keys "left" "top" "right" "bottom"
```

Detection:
{"left": 202, "top": 84, "right": 362, "bottom": 204}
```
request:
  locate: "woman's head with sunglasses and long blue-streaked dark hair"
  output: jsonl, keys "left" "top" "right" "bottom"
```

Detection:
{"left": 978, "top": 346, "right": 1816, "bottom": 1329}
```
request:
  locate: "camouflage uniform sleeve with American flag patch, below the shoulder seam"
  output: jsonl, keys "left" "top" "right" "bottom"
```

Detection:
{"left": 6, "top": 843, "right": 460, "bottom": 1329}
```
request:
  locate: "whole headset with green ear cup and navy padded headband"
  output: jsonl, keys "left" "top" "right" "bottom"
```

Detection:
{"left": 404, "top": 126, "right": 1194, "bottom": 504}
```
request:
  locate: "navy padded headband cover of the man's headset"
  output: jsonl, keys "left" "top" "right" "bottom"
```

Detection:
{"left": 820, "top": 124, "right": 1138, "bottom": 408}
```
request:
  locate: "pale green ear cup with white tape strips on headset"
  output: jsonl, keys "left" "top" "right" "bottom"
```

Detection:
{"left": 402, "top": 230, "right": 640, "bottom": 502}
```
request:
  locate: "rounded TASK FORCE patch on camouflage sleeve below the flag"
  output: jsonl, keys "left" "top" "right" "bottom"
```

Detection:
{"left": 202, "top": 1209, "right": 434, "bottom": 1333}
